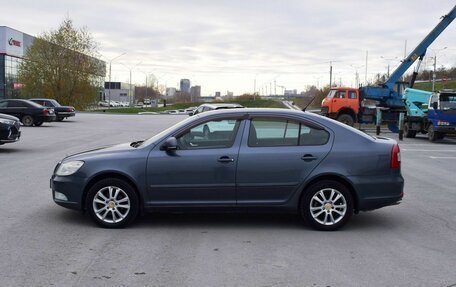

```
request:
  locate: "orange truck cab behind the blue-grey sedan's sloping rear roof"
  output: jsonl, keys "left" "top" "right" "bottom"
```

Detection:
{"left": 321, "top": 87, "right": 360, "bottom": 126}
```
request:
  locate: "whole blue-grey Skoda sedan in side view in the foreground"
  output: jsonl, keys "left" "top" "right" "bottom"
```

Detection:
{"left": 51, "top": 109, "right": 404, "bottom": 230}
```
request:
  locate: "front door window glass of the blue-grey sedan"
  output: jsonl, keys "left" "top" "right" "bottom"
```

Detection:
{"left": 177, "top": 119, "right": 240, "bottom": 149}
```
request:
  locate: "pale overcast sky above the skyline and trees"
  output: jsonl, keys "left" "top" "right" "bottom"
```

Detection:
{"left": 0, "top": 0, "right": 456, "bottom": 95}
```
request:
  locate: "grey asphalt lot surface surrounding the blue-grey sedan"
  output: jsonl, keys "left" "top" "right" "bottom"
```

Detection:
{"left": 0, "top": 113, "right": 456, "bottom": 287}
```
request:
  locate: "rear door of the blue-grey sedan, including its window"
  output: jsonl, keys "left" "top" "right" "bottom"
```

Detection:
{"left": 236, "top": 117, "right": 331, "bottom": 205}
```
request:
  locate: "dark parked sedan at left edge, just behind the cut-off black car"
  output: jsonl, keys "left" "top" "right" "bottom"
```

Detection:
{"left": 0, "top": 99, "right": 56, "bottom": 126}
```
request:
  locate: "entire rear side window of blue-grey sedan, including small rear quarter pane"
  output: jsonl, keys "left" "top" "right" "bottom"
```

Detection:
{"left": 248, "top": 119, "right": 329, "bottom": 147}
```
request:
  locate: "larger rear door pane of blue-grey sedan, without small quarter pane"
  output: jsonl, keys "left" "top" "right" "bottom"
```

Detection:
{"left": 248, "top": 119, "right": 299, "bottom": 147}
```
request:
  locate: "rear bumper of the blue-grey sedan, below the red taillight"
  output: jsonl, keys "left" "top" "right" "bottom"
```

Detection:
{"left": 349, "top": 174, "right": 404, "bottom": 211}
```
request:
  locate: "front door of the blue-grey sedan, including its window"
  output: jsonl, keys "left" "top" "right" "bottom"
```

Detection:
{"left": 146, "top": 118, "right": 243, "bottom": 206}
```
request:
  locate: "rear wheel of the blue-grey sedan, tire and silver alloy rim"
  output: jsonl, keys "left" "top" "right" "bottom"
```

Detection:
{"left": 300, "top": 180, "right": 353, "bottom": 231}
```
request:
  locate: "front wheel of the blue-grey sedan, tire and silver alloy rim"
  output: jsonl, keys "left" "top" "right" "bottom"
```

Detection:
{"left": 86, "top": 178, "right": 139, "bottom": 228}
